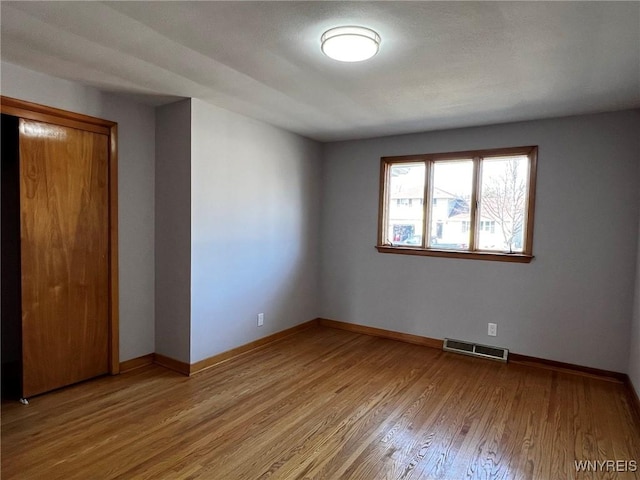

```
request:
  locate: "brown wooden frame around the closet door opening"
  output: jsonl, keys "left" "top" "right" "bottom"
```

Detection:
{"left": 0, "top": 96, "right": 120, "bottom": 375}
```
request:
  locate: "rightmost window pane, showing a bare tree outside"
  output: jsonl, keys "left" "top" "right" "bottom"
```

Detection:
{"left": 478, "top": 155, "right": 529, "bottom": 252}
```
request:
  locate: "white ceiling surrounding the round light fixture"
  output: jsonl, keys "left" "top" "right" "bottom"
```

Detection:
{"left": 0, "top": 1, "right": 640, "bottom": 141}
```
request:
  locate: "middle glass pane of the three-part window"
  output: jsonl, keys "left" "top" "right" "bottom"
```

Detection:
{"left": 429, "top": 160, "right": 473, "bottom": 250}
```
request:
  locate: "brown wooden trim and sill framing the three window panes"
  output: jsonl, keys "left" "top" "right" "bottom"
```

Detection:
{"left": 375, "top": 146, "right": 538, "bottom": 263}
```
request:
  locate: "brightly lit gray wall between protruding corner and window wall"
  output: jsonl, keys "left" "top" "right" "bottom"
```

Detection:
{"left": 191, "top": 99, "right": 322, "bottom": 362}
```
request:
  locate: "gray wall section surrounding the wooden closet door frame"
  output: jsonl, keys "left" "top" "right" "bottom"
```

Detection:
{"left": 1, "top": 62, "right": 155, "bottom": 361}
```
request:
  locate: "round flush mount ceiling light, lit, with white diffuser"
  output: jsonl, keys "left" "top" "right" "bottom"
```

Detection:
{"left": 320, "top": 27, "right": 380, "bottom": 62}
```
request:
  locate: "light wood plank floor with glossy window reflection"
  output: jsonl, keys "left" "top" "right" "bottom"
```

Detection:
{"left": 2, "top": 327, "right": 640, "bottom": 480}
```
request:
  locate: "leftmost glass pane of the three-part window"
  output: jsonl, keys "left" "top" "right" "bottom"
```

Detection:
{"left": 384, "top": 163, "right": 425, "bottom": 247}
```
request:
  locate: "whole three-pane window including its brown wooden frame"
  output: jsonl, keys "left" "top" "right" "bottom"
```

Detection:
{"left": 376, "top": 147, "right": 538, "bottom": 263}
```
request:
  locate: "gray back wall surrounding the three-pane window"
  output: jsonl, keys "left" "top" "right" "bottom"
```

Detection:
{"left": 320, "top": 110, "right": 640, "bottom": 372}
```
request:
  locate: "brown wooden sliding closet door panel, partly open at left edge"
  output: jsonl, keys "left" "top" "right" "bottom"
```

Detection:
{"left": 19, "top": 119, "right": 109, "bottom": 397}
